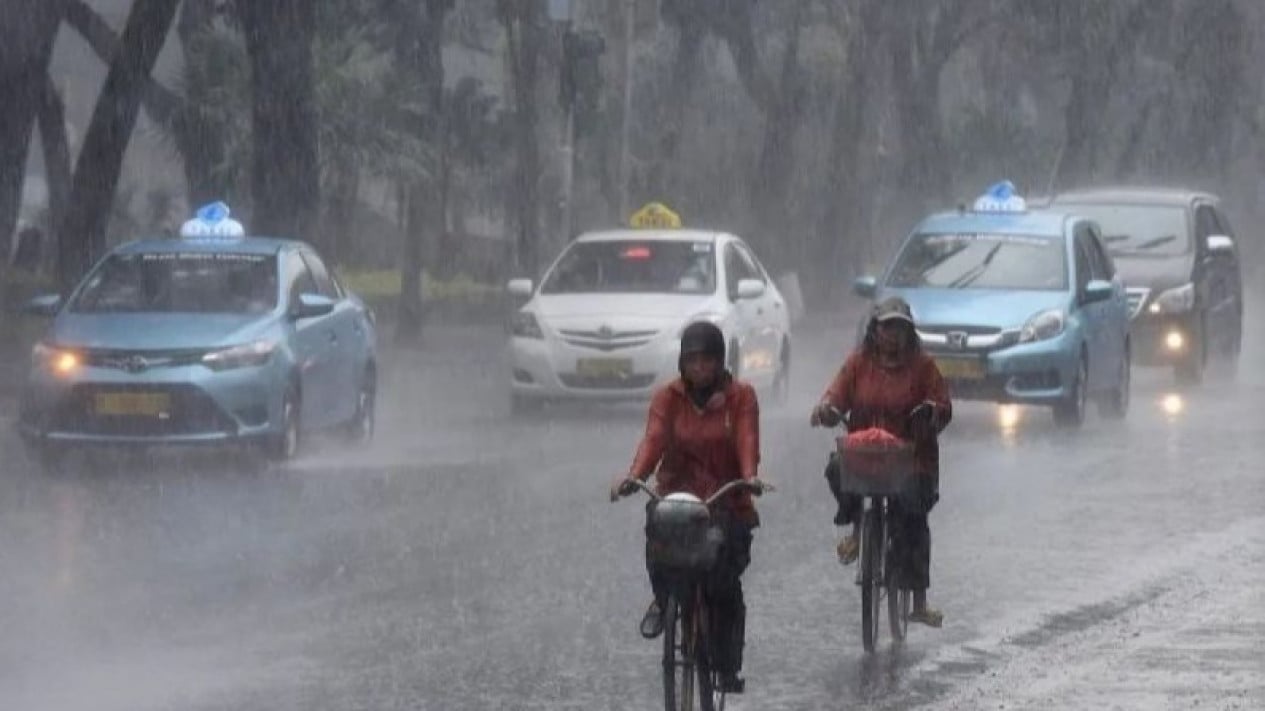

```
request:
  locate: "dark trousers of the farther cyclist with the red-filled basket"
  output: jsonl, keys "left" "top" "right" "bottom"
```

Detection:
{"left": 826, "top": 455, "right": 940, "bottom": 590}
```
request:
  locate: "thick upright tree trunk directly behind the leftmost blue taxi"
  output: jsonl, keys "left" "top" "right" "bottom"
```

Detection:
{"left": 235, "top": 0, "right": 320, "bottom": 239}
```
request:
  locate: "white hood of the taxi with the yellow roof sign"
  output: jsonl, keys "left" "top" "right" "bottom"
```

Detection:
{"left": 533, "top": 294, "right": 712, "bottom": 328}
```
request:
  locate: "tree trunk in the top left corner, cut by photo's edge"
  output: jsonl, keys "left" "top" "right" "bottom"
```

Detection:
{"left": 0, "top": 0, "right": 62, "bottom": 259}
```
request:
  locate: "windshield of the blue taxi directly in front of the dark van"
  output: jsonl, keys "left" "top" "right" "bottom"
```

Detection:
{"left": 887, "top": 233, "right": 1068, "bottom": 291}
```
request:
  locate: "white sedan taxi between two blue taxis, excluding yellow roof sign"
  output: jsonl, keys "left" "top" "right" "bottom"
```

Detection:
{"left": 509, "top": 229, "right": 791, "bottom": 411}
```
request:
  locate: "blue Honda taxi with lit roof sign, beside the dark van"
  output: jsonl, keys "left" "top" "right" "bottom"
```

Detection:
{"left": 854, "top": 181, "right": 1131, "bottom": 426}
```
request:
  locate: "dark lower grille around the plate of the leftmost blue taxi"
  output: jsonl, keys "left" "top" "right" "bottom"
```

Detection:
{"left": 51, "top": 383, "right": 237, "bottom": 436}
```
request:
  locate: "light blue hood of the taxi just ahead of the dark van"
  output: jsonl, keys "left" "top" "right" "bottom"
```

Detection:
{"left": 879, "top": 288, "right": 1071, "bottom": 329}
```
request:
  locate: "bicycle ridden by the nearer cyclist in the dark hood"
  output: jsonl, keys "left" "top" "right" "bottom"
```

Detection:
{"left": 612, "top": 478, "right": 773, "bottom": 711}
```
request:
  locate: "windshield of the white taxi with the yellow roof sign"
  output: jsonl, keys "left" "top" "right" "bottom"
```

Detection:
{"left": 540, "top": 240, "right": 716, "bottom": 294}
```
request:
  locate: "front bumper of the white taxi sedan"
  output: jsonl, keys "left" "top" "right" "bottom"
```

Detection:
{"left": 510, "top": 334, "right": 681, "bottom": 401}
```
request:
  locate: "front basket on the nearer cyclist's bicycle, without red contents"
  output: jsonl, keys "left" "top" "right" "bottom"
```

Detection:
{"left": 646, "top": 493, "right": 721, "bottom": 571}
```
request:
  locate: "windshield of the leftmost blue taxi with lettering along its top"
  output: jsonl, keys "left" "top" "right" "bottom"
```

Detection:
{"left": 71, "top": 253, "right": 277, "bottom": 314}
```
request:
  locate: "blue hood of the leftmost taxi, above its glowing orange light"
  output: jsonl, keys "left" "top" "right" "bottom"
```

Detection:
{"left": 49, "top": 311, "right": 276, "bottom": 350}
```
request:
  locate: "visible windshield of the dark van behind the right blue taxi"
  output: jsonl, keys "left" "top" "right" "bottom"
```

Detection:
{"left": 1060, "top": 204, "right": 1190, "bottom": 257}
